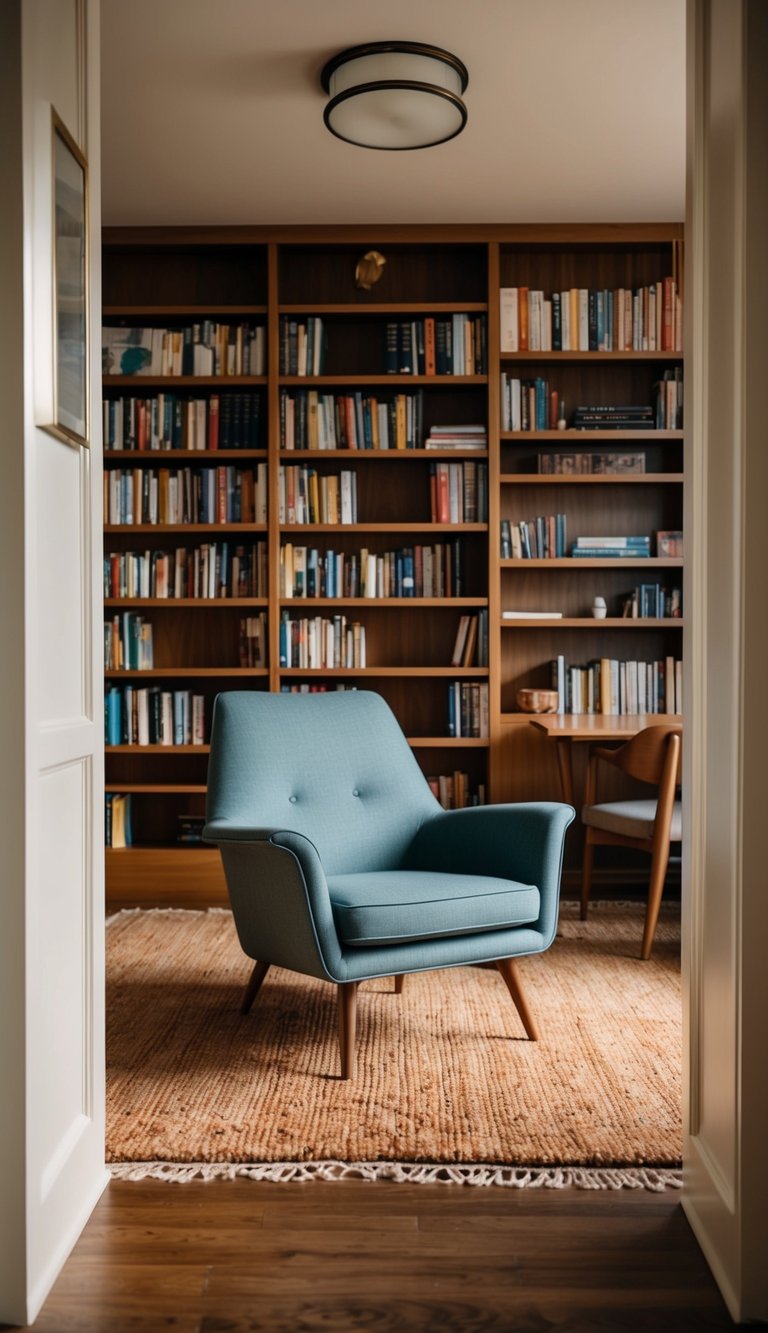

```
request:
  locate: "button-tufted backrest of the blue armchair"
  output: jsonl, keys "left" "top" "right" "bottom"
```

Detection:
{"left": 207, "top": 690, "right": 440, "bottom": 874}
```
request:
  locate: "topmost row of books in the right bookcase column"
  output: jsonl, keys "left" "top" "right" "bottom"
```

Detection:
{"left": 499, "top": 276, "right": 683, "bottom": 352}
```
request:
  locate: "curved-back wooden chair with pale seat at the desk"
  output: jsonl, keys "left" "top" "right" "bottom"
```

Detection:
{"left": 581, "top": 724, "right": 683, "bottom": 960}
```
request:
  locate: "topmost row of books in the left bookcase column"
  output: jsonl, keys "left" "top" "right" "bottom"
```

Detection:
{"left": 101, "top": 320, "right": 267, "bottom": 376}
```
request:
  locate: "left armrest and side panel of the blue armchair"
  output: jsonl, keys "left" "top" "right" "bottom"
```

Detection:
{"left": 203, "top": 818, "right": 341, "bottom": 980}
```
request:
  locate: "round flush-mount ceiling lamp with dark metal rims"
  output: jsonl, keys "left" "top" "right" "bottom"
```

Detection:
{"left": 320, "top": 41, "right": 469, "bottom": 151}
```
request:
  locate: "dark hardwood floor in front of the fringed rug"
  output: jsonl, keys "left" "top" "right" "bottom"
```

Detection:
{"left": 6, "top": 1180, "right": 733, "bottom": 1333}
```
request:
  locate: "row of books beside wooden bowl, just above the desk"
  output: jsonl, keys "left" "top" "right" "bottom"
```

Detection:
{"left": 551, "top": 655, "right": 683, "bottom": 716}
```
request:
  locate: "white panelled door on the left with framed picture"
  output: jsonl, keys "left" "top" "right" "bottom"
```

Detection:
{"left": 0, "top": 0, "right": 107, "bottom": 1322}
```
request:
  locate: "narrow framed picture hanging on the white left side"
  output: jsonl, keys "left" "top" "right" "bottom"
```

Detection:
{"left": 48, "top": 111, "right": 89, "bottom": 445}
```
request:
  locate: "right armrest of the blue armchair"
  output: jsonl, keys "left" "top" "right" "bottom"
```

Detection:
{"left": 405, "top": 801, "right": 576, "bottom": 940}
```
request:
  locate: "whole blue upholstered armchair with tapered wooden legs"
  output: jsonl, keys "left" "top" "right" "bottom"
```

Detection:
{"left": 204, "top": 690, "right": 573, "bottom": 1078}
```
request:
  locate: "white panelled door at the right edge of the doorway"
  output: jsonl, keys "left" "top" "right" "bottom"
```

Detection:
{"left": 684, "top": 0, "right": 768, "bottom": 1321}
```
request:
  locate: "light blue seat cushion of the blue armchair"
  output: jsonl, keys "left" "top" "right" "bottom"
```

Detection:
{"left": 328, "top": 870, "right": 540, "bottom": 945}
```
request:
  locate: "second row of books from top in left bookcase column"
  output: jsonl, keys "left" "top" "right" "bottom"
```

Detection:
{"left": 101, "top": 392, "right": 261, "bottom": 453}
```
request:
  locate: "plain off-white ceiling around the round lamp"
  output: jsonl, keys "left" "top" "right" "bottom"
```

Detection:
{"left": 101, "top": 0, "right": 685, "bottom": 225}
